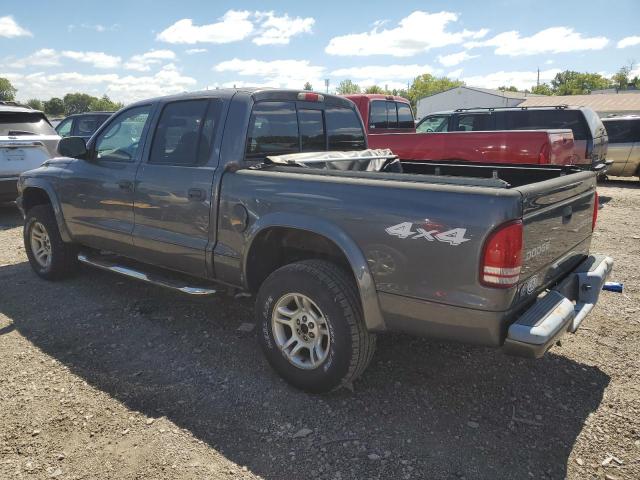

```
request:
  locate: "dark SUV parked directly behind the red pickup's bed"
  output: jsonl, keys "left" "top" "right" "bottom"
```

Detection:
{"left": 416, "top": 105, "right": 608, "bottom": 173}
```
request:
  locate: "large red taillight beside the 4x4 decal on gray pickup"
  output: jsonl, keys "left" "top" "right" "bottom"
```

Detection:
{"left": 480, "top": 220, "right": 523, "bottom": 288}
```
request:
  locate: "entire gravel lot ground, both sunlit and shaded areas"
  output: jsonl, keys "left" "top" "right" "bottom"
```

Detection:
{"left": 0, "top": 181, "right": 640, "bottom": 480}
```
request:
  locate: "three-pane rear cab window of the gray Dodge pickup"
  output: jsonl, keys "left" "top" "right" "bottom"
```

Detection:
{"left": 245, "top": 101, "right": 366, "bottom": 160}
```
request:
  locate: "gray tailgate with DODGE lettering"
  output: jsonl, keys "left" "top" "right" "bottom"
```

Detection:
{"left": 518, "top": 172, "right": 596, "bottom": 300}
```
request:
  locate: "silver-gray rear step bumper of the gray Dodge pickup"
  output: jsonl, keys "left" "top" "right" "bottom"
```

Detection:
{"left": 504, "top": 255, "right": 613, "bottom": 358}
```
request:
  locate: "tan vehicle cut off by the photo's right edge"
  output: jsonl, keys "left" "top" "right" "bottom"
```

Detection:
{"left": 602, "top": 115, "right": 640, "bottom": 181}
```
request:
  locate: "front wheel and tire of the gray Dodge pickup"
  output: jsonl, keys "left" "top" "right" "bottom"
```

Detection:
{"left": 23, "top": 205, "right": 78, "bottom": 280}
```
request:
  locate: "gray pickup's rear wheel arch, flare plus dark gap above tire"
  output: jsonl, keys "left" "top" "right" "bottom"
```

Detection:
{"left": 242, "top": 213, "right": 385, "bottom": 331}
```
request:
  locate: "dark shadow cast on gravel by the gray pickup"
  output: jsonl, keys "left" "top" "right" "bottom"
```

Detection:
{"left": 0, "top": 262, "right": 610, "bottom": 480}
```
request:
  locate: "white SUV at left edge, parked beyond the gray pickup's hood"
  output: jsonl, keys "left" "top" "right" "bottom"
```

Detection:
{"left": 0, "top": 102, "right": 60, "bottom": 202}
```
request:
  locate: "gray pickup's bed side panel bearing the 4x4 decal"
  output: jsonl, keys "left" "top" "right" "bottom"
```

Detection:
{"left": 216, "top": 170, "right": 521, "bottom": 311}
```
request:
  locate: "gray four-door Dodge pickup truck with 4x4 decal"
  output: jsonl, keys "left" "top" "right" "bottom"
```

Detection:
{"left": 18, "top": 89, "right": 613, "bottom": 392}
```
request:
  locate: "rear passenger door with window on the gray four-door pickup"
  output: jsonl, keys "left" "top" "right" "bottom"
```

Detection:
{"left": 133, "top": 98, "right": 222, "bottom": 276}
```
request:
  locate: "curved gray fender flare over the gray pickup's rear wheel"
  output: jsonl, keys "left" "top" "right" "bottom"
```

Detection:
{"left": 242, "top": 212, "right": 386, "bottom": 331}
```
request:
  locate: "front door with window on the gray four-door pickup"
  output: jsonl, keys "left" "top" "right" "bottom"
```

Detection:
{"left": 59, "top": 104, "right": 153, "bottom": 253}
